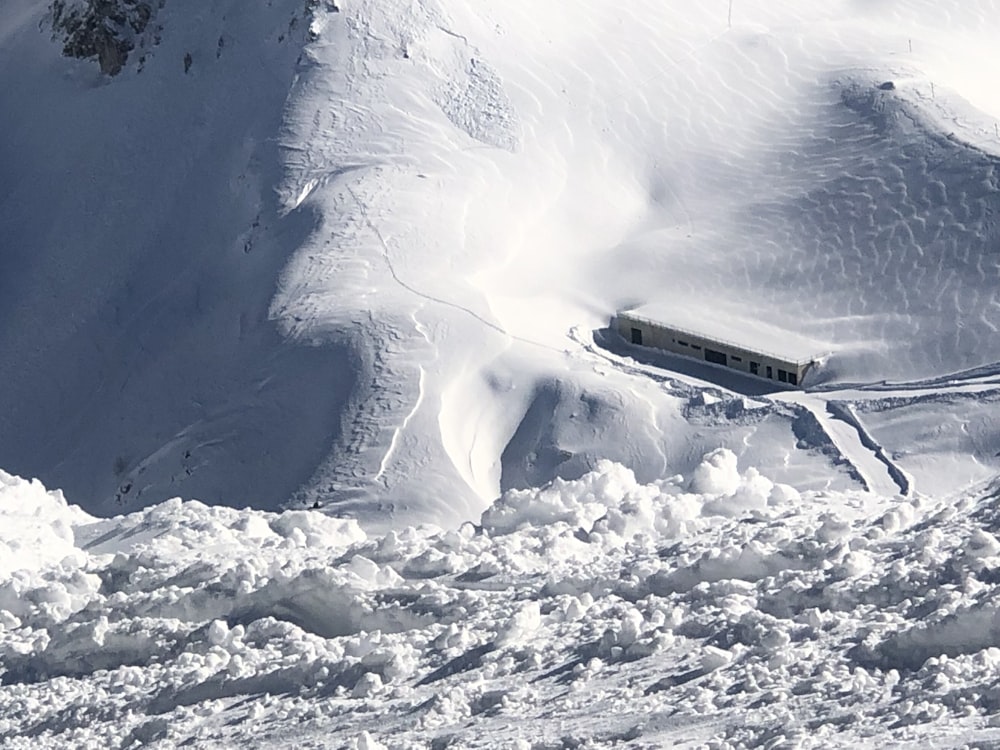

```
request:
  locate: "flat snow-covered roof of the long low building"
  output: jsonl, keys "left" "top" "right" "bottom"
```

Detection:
{"left": 620, "top": 303, "right": 831, "bottom": 364}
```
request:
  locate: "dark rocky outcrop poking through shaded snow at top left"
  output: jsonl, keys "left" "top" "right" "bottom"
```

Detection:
{"left": 49, "top": 0, "right": 164, "bottom": 76}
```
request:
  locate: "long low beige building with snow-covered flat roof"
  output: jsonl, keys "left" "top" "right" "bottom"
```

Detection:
{"left": 613, "top": 305, "right": 825, "bottom": 388}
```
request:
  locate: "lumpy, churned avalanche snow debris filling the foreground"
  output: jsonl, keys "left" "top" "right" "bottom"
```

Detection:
{"left": 9, "top": 462, "right": 1000, "bottom": 749}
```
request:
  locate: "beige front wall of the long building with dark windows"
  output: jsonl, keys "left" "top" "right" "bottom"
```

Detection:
{"left": 615, "top": 315, "right": 812, "bottom": 387}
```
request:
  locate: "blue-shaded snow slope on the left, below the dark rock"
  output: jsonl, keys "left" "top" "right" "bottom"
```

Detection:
{"left": 0, "top": 0, "right": 355, "bottom": 512}
